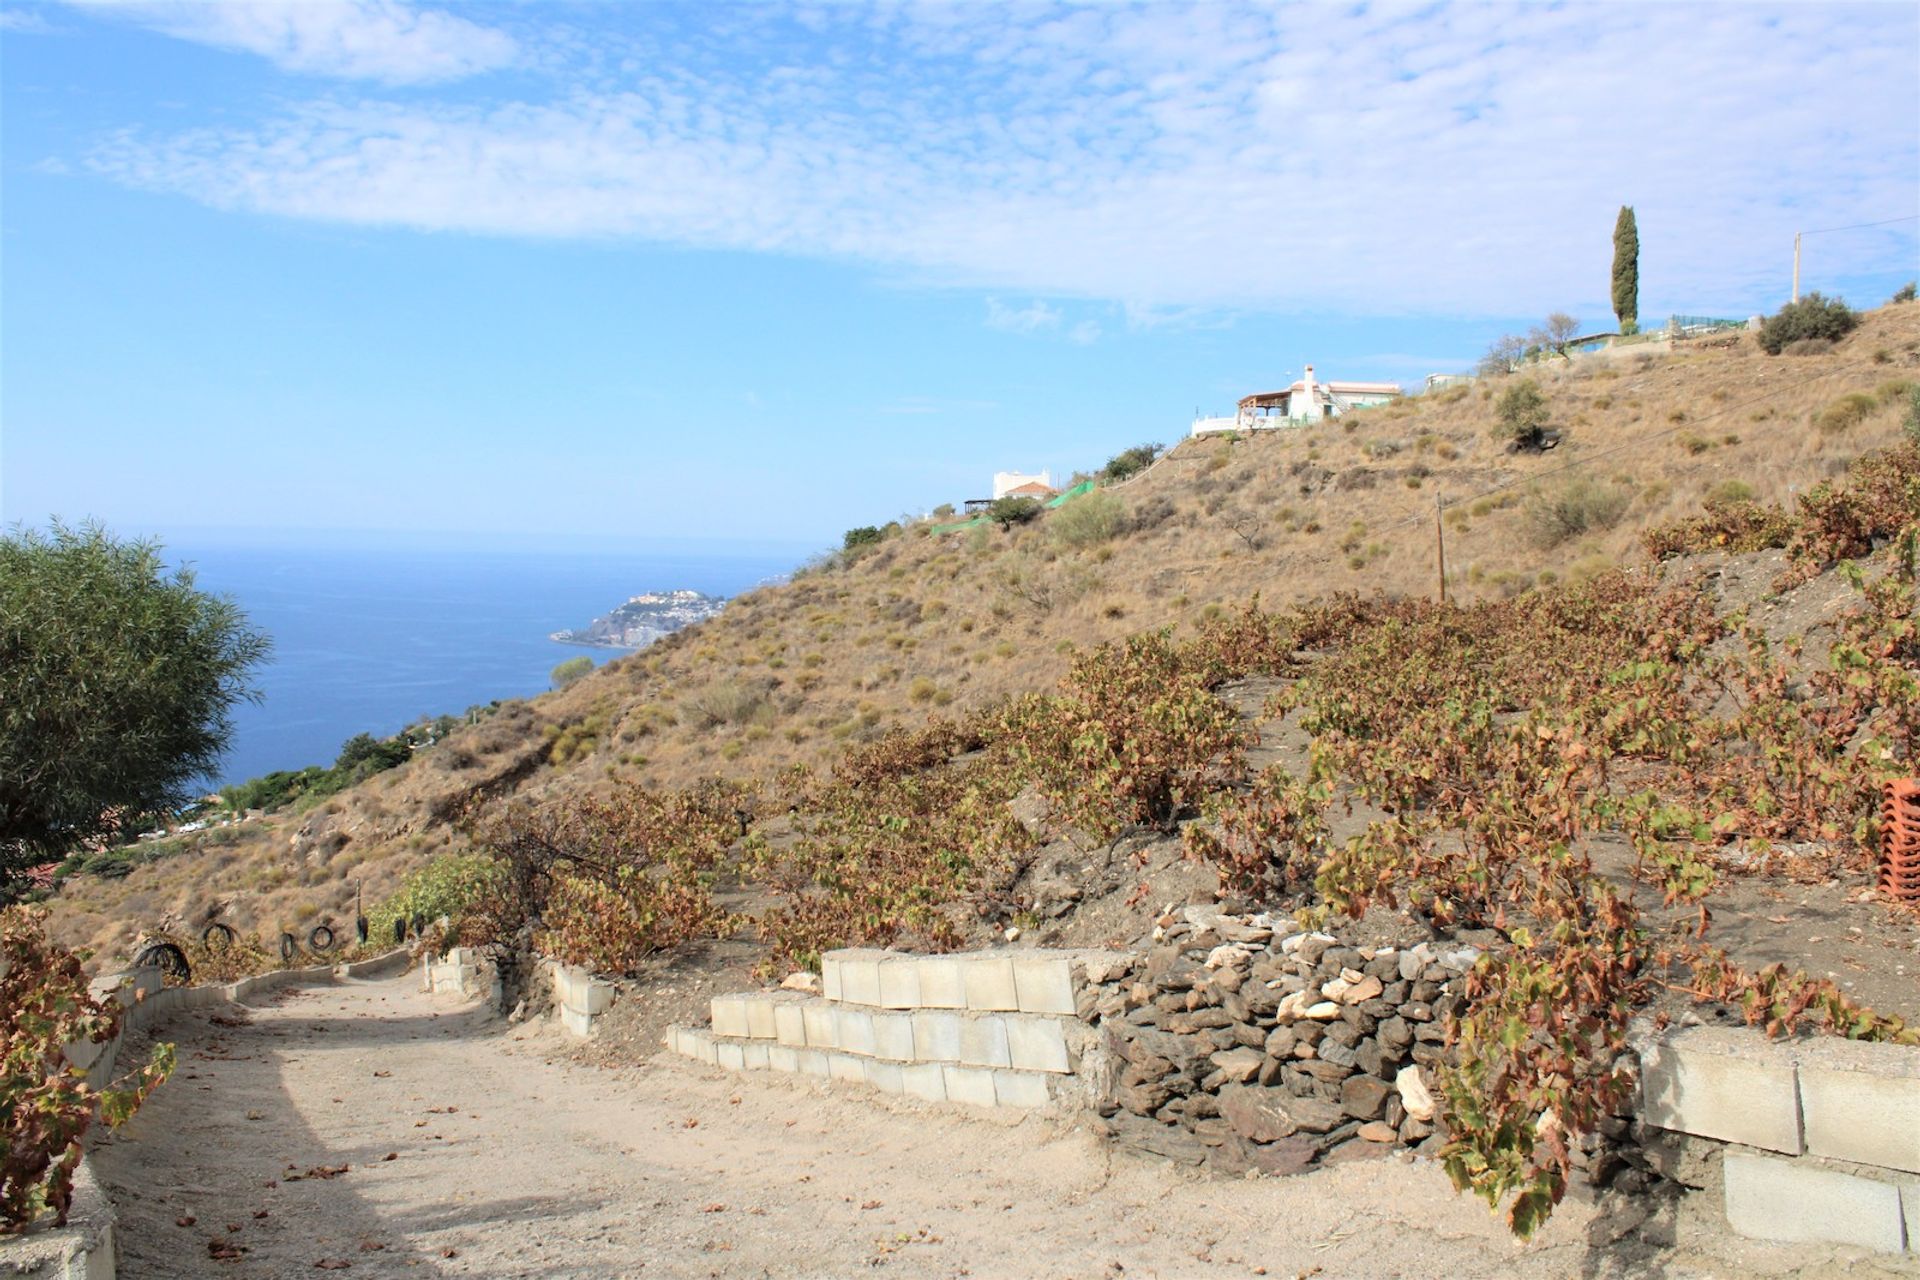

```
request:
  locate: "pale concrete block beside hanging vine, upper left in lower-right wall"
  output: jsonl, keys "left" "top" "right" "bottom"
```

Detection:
{"left": 1640, "top": 1027, "right": 1801, "bottom": 1155}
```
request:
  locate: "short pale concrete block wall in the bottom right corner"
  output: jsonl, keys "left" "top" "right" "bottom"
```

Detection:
{"left": 1636, "top": 1027, "right": 1920, "bottom": 1253}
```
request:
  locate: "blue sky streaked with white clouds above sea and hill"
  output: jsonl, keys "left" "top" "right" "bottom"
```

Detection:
{"left": 0, "top": 0, "right": 1920, "bottom": 549}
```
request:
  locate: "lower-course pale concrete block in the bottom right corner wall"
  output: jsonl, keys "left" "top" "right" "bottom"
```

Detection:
{"left": 1726, "top": 1151, "right": 1907, "bottom": 1253}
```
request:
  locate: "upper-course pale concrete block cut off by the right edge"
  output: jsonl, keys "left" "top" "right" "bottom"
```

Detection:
{"left": 1793, "top": 1038, "right": 1920, "bottom": 1173}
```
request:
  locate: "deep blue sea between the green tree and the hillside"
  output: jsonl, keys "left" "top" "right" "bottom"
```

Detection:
{"left": 163, "top": 541, "right": 799, "bottom": 787}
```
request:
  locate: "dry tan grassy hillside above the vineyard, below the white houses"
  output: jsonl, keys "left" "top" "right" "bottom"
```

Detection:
{"left": 54, "top": 305, "right": 1920, "bottom": 956}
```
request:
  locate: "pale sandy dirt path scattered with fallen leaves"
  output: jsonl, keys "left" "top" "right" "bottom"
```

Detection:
{"left": 96, "top": 977, "right": 1884, "bottom": 1280}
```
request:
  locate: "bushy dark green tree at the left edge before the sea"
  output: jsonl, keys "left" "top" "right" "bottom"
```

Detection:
{"left": 0, "top": 522, "right": 269, "bottom": 900}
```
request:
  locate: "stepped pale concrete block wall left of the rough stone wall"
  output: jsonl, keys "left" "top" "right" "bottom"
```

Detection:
{"left": 666, "top": 950, "right": 1131, "bottom": 1111}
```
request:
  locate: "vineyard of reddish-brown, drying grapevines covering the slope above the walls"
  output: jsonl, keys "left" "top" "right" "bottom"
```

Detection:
{"left": 337, "top": 445, "right": 1920, "bottom": 1234}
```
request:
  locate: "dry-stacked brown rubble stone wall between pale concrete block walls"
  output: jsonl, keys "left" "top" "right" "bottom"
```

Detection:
{"left": 1094, "top": 906, "right": 1480, "bottom": 1173}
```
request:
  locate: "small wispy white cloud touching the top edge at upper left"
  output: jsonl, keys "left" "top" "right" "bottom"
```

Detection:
{"left": 69, "top": 0, "right": 516, "bottom": 84}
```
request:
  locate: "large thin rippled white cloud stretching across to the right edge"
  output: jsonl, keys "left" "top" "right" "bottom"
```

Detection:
{"left": 74, "top": 4, "right": 1920, "bottom": 318}
